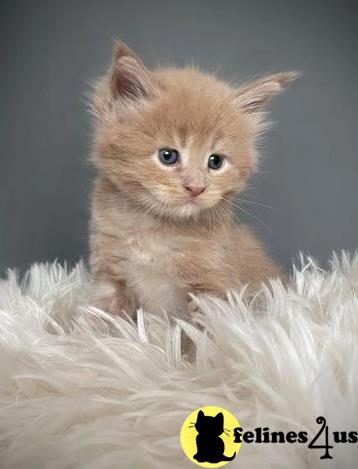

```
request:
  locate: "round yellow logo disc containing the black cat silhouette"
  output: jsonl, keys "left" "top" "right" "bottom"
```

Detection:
{"left": 180, "top": 406, "right": 241, "bottom": 467}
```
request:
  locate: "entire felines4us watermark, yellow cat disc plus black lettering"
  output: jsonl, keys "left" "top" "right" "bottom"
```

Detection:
{"left": 180, "top": 406, "right": 358, "bottom": 467}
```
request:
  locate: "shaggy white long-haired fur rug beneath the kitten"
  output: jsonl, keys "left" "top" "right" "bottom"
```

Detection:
{"left": 0, "top": 254, "right": 358, "bottom": 469}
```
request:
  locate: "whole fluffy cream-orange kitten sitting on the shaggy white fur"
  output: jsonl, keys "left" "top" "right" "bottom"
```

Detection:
{"left": 90, "top": 43, "right": 296, "bottom": 314}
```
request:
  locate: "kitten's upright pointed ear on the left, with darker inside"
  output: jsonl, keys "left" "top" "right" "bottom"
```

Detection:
{"left": 109, "top": 41, "right": 155, "bottom": 102}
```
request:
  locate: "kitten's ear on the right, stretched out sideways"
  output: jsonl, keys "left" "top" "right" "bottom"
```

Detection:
{"left": 235, "top": 72, "right": 300, "bottom": 114}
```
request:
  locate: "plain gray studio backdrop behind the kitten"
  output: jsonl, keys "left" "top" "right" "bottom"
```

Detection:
{"left": 0, "top": 0, "right": 358, "bottom": 270}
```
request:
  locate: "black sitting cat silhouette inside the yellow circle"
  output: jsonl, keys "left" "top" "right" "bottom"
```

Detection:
{"left": 193, "top": 410, "right": 236, "bottom": 464}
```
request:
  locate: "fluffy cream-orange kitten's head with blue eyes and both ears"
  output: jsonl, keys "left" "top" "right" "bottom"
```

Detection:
{"left": 92, "top": 43, "right": 296, "bottom": 218}
